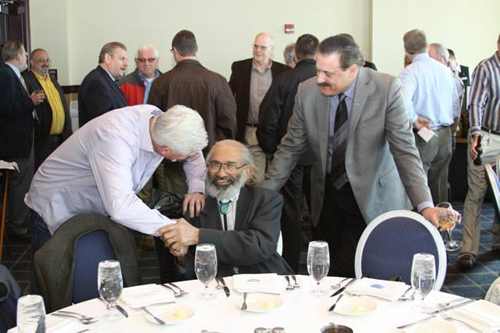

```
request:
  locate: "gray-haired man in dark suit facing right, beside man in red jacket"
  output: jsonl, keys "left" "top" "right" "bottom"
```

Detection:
{"left": 78, "top": 42, "right": 128, "bottom": 127}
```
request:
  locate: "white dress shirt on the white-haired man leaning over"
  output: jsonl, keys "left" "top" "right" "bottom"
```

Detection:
{"left": 25, "top": 105, "right": 206, "bottom": 234}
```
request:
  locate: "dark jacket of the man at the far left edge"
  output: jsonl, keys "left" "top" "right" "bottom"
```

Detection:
{"left": 0, "top": 64, "right": 34, "bottom": 160}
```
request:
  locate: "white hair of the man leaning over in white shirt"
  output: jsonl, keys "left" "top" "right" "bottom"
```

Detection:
{"left": 151, "top": 105, "right": 208, "bottom": 156}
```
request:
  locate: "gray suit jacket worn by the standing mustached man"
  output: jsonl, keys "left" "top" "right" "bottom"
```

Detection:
{"left": 263, "top": 68, "right": 432, "bottom": 225}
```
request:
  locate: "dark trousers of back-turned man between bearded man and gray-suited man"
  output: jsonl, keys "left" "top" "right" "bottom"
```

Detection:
{"left": 280, "top": 165, "right": 311, "bottom": 273}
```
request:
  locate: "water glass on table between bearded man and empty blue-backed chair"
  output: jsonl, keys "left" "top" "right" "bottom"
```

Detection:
{"left": 307, "top": 241, "right": 330, "bottom": 296}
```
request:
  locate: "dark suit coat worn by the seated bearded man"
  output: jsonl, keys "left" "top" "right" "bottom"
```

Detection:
{"left": 179, "top": 187, "right": 293, "bottom": 278}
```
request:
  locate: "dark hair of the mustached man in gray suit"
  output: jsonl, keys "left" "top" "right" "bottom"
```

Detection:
{"left": 318, "top": 34, "right": 365, "bottom": 70}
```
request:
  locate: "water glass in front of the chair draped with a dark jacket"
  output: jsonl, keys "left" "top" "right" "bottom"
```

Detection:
{"left": 97, "top": 260, "right": 123, "bottom": 321}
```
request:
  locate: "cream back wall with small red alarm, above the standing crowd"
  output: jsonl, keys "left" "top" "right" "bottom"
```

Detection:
{"left": 30, "top": 0, "right": 371, "bottom": 85}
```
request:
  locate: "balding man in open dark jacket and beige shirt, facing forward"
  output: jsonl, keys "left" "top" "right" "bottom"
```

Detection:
{"left": 229, "top": 33, "right": 290, "bottom": 184}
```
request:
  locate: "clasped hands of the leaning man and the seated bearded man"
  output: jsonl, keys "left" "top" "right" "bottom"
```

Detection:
{"left": 157, "top": 218, "right": 200, "bottom": 250}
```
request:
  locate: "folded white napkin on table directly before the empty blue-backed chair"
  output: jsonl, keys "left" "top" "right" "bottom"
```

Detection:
{"left": 347, "top": 278, "right": 408, "bottom": 301}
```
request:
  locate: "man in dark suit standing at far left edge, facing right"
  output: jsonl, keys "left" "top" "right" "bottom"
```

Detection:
{"left": 0, "top": 41, "right": 45, "bottom": 239}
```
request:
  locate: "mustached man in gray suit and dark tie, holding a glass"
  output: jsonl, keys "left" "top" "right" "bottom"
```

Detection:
{"left": 263, "top": 35, "right": 444, "bottom": 276}
